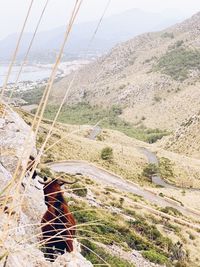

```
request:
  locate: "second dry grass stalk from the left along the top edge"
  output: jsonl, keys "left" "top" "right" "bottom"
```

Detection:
{"left": 8, "top": 0, "right": 49, "bottom": 104}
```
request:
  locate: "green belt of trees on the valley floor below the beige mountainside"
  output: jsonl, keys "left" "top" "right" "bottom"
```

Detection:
{"left": 39, "top": 103, "right": 169, "bottom": 143}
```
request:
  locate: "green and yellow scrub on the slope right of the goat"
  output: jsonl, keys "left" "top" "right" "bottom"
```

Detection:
{"left": 67, "top": 196, "right": 183, "bottom": 266}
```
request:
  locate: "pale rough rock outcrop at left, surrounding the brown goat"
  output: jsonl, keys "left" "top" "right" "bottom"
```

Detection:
{"left": 0, "top": 103, "right": 92, "bottom": 267}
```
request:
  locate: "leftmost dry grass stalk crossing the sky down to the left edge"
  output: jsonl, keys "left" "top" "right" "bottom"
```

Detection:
{"left": 0, "top": 0, "right": 34, "bottom": 100}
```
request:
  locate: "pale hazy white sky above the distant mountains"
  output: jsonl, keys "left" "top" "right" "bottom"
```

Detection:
{"left": 0, "top": 0, "right": 200, "bottom": 39}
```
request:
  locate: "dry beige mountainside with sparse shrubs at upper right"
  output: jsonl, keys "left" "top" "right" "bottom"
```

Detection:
{"left": 51, "top": 13, "right": 200, "bottom": 130}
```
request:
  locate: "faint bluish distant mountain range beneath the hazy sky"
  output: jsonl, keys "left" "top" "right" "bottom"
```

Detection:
{"left": 0, "top": 9, "right": 185, "bottom": 62}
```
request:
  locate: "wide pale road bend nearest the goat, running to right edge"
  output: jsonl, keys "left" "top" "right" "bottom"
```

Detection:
{"left": 48, "top": 161, "right": 200, "bottom": 218}
